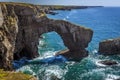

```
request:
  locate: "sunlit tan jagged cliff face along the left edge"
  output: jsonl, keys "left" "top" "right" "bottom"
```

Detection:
{"left": 0, "top": 4, "right": 18, "bottom": 70}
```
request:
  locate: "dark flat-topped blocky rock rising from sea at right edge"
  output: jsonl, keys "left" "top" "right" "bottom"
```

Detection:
{"left": 99, "top": 38, "right": 120, "bottom": 55}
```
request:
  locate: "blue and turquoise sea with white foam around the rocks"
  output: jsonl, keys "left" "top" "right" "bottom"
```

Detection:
{"left": 16, "top": 7, "right": 120, "bottom": 80}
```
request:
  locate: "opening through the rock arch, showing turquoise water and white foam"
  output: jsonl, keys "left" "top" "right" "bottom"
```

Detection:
{"left": 38, "top": 31, "right": 67, "bottom": 57}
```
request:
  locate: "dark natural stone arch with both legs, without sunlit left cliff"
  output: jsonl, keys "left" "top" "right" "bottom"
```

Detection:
{"left": 14, "top": 18, "right": 93, "bottom": 60}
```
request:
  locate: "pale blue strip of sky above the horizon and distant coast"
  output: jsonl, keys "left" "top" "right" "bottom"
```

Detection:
{"left": 0, "top": 0, "right": 120, "bottom": 6}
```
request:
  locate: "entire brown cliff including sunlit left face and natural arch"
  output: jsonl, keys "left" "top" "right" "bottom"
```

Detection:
{"left": 0, "top": 3, "right": 93, "bottom": 69}
